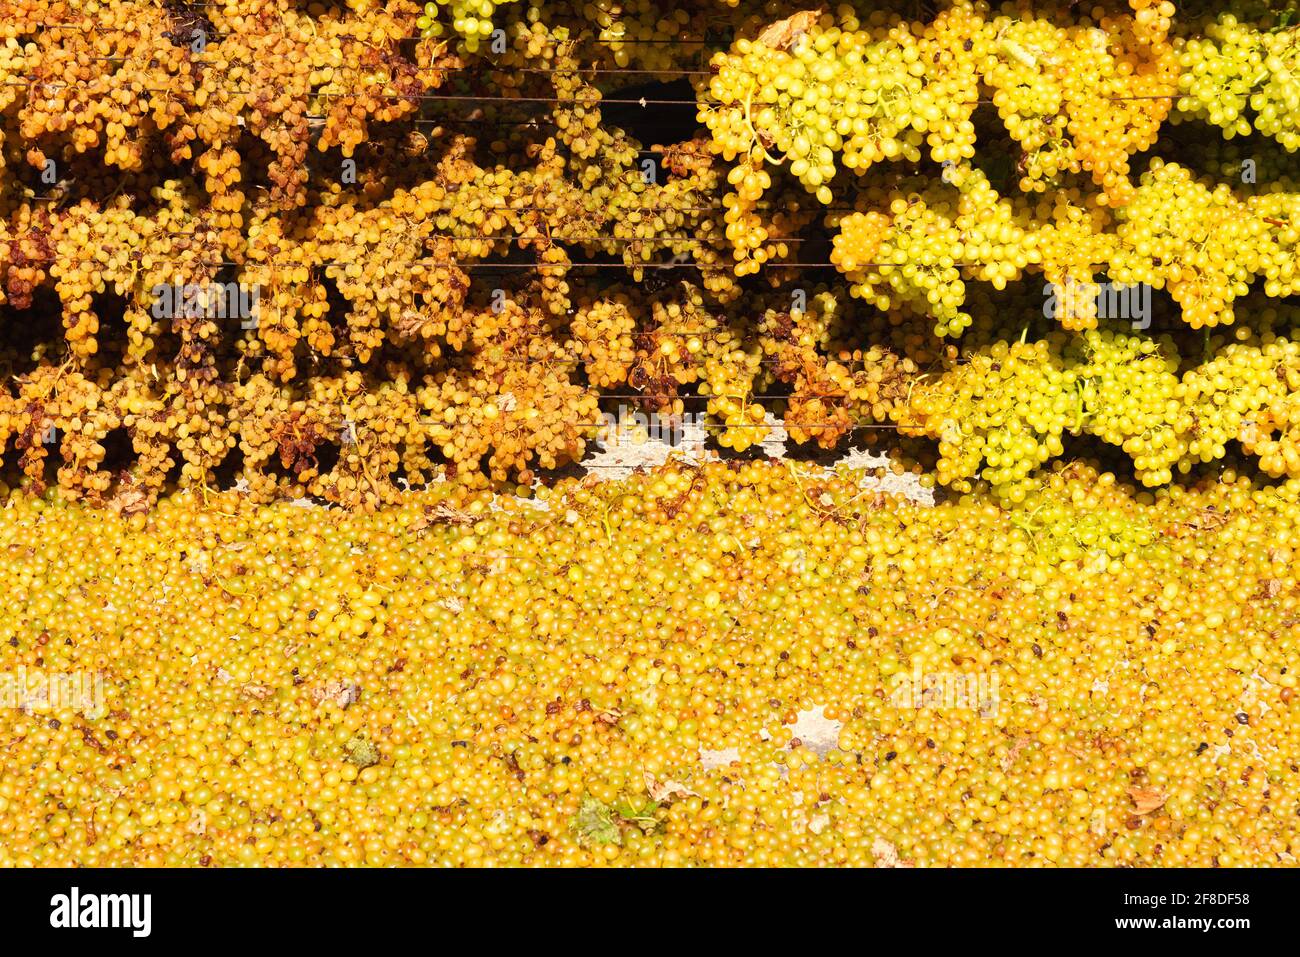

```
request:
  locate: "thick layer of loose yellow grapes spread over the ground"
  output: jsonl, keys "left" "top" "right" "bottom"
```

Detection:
{"left": 0, "top": 463, "right": 1300, "bottom": 866}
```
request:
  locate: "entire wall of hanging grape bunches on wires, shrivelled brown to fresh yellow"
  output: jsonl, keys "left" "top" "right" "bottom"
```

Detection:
{"left": 0, "top": 0, "right": 1300, "bottom": 510}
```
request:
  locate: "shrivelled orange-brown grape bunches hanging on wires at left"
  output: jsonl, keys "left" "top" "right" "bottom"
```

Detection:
{"left": 0, "top": 3, "right": 754, "bottom": 508}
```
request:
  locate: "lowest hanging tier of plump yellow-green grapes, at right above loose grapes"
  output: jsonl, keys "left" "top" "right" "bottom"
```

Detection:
{"left": 891, "top": 314, "right": 1300, "bottom": 502}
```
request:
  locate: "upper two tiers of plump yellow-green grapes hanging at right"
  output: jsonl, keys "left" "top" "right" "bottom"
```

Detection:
{"left": 699, "top": 3, "right": 1300, "bottom": 345}
